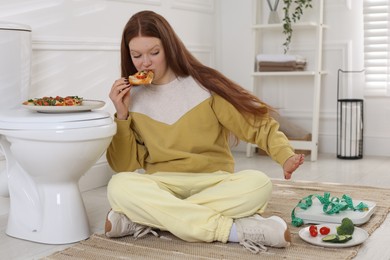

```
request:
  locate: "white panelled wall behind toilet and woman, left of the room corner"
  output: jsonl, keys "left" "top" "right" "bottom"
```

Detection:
{"left": 0, "top": 0, "right": 216, "bottom": 191}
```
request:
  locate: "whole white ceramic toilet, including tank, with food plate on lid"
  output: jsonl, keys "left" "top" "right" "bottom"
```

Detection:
{"left": 0, "top": 22, "right": 116, "bottom": 244}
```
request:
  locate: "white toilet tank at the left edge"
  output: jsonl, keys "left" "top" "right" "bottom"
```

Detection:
{"left": 0, "top": 21, "right": 31, "bottom": 111}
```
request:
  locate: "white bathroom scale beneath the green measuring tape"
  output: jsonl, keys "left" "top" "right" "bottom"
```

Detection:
{"left": 295, "top": 197, "right": 376, "bottom": 225}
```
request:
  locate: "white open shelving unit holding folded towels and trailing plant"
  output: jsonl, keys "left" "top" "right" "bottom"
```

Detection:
{"left": 247, "top": 0, "right": 326, "bottom": 161}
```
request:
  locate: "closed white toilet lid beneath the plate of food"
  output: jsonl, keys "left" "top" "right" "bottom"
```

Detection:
{"left": 0, "top": 109, "right": 113, "bottom": 130}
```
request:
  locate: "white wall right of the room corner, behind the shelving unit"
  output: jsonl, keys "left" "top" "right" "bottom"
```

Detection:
{"left": 217, "top": 0, "right": 390, "bottom": 156}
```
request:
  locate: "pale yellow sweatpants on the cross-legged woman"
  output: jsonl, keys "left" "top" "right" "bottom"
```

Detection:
{"left": 107, "top": 170, "right": 272, "bottom": 243}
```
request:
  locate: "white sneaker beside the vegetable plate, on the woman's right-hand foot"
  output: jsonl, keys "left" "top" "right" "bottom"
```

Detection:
{"left": 235, "top": 214, "right": 291, "bottom": 253}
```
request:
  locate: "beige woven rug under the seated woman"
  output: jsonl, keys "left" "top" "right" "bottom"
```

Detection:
{"left": 44, "top": 180, "right": 390, "bottom": 260}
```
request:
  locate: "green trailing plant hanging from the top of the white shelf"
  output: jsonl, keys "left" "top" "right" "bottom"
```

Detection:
{"left": 282, "top": 0, "right": 312, "bottom": 54}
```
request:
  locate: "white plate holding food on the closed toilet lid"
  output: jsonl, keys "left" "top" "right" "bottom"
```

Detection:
{"left": 22, "top": 100, "right": 106, "bottom": 113}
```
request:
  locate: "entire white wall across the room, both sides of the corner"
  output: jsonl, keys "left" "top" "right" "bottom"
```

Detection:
{"left": 0, "top": 0, "right": 390, "bottom": 197}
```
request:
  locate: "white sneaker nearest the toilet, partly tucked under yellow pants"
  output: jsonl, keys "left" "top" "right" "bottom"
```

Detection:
{"left": 104, "top": 210, "right": 158, "bottom": 238}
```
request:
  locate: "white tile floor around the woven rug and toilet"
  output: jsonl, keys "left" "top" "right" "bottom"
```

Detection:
{"left": 0, "top": 153, "right": 390, "bottom": 260}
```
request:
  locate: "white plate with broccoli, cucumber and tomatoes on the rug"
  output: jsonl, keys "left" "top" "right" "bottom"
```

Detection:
{"left": 299, "top": 224, "right": 369, "bottom": 247}
